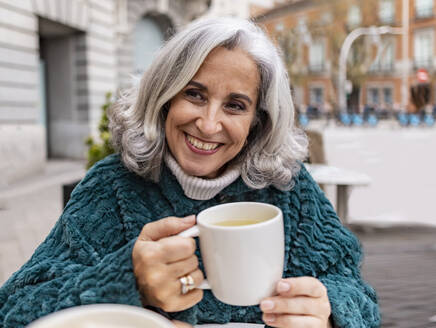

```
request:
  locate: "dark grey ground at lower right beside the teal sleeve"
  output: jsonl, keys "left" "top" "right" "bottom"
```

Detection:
{"left": 353, "top": 227, "right": 436, "bottom": 328}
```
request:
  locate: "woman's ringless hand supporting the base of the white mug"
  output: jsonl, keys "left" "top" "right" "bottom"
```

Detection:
{"left": 260, "top": 277, "right": 331, "bottom": 328}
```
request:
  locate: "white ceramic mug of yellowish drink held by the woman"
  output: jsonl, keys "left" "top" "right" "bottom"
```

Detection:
{"left": 179, "top": 202, "right": 285, "bottom": 306}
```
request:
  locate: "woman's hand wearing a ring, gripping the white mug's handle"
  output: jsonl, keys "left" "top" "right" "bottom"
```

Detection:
{"left": 132, "top": 215, "right": 204, "bottom": 312}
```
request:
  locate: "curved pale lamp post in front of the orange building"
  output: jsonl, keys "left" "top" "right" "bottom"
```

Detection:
{"left": 338, "top": 24, "right": 407, "bottom": 111}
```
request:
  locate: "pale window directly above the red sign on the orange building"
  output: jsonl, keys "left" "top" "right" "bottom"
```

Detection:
{"left": 413, "top": 29, "right": 434, "bottom": 68}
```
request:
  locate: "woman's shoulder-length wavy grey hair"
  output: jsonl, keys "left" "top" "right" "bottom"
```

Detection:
{"left": 109, "top": 18, "right": 308, "bottom": 190}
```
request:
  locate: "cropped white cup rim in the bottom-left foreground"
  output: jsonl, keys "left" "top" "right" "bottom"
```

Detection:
{"left": 27, "top": 304, "right": 175, "bottom": 328}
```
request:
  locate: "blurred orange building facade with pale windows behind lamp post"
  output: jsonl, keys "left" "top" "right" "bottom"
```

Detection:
{"left": 255, "top": 0, "right": 436, "bottom": 116}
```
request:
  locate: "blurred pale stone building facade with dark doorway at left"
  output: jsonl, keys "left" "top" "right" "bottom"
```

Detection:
{"left": 0, "top": 0, "right": 210, "bottom": 185}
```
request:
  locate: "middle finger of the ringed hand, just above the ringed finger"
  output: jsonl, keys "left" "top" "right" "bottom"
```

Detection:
{"left": 158, "top": 236, "right": 196, "bottom": 264}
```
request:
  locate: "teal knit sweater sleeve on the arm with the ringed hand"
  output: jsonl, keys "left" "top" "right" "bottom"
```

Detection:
{"left": 0, "top": 157, "right": 141, "bottom": 328}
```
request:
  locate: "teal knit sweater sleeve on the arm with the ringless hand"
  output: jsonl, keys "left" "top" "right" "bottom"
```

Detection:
{"left": 290, "top": 169, "right": 380, "bottom": 328}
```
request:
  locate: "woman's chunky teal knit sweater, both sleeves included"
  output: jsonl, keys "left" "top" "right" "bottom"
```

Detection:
{"left": 0, "top": 155, "right": 380, "bottom": 328}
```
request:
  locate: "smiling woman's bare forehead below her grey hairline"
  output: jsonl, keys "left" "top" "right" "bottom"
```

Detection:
{"left": 194, "top": 47, "right": 260, "bottom": 93}
